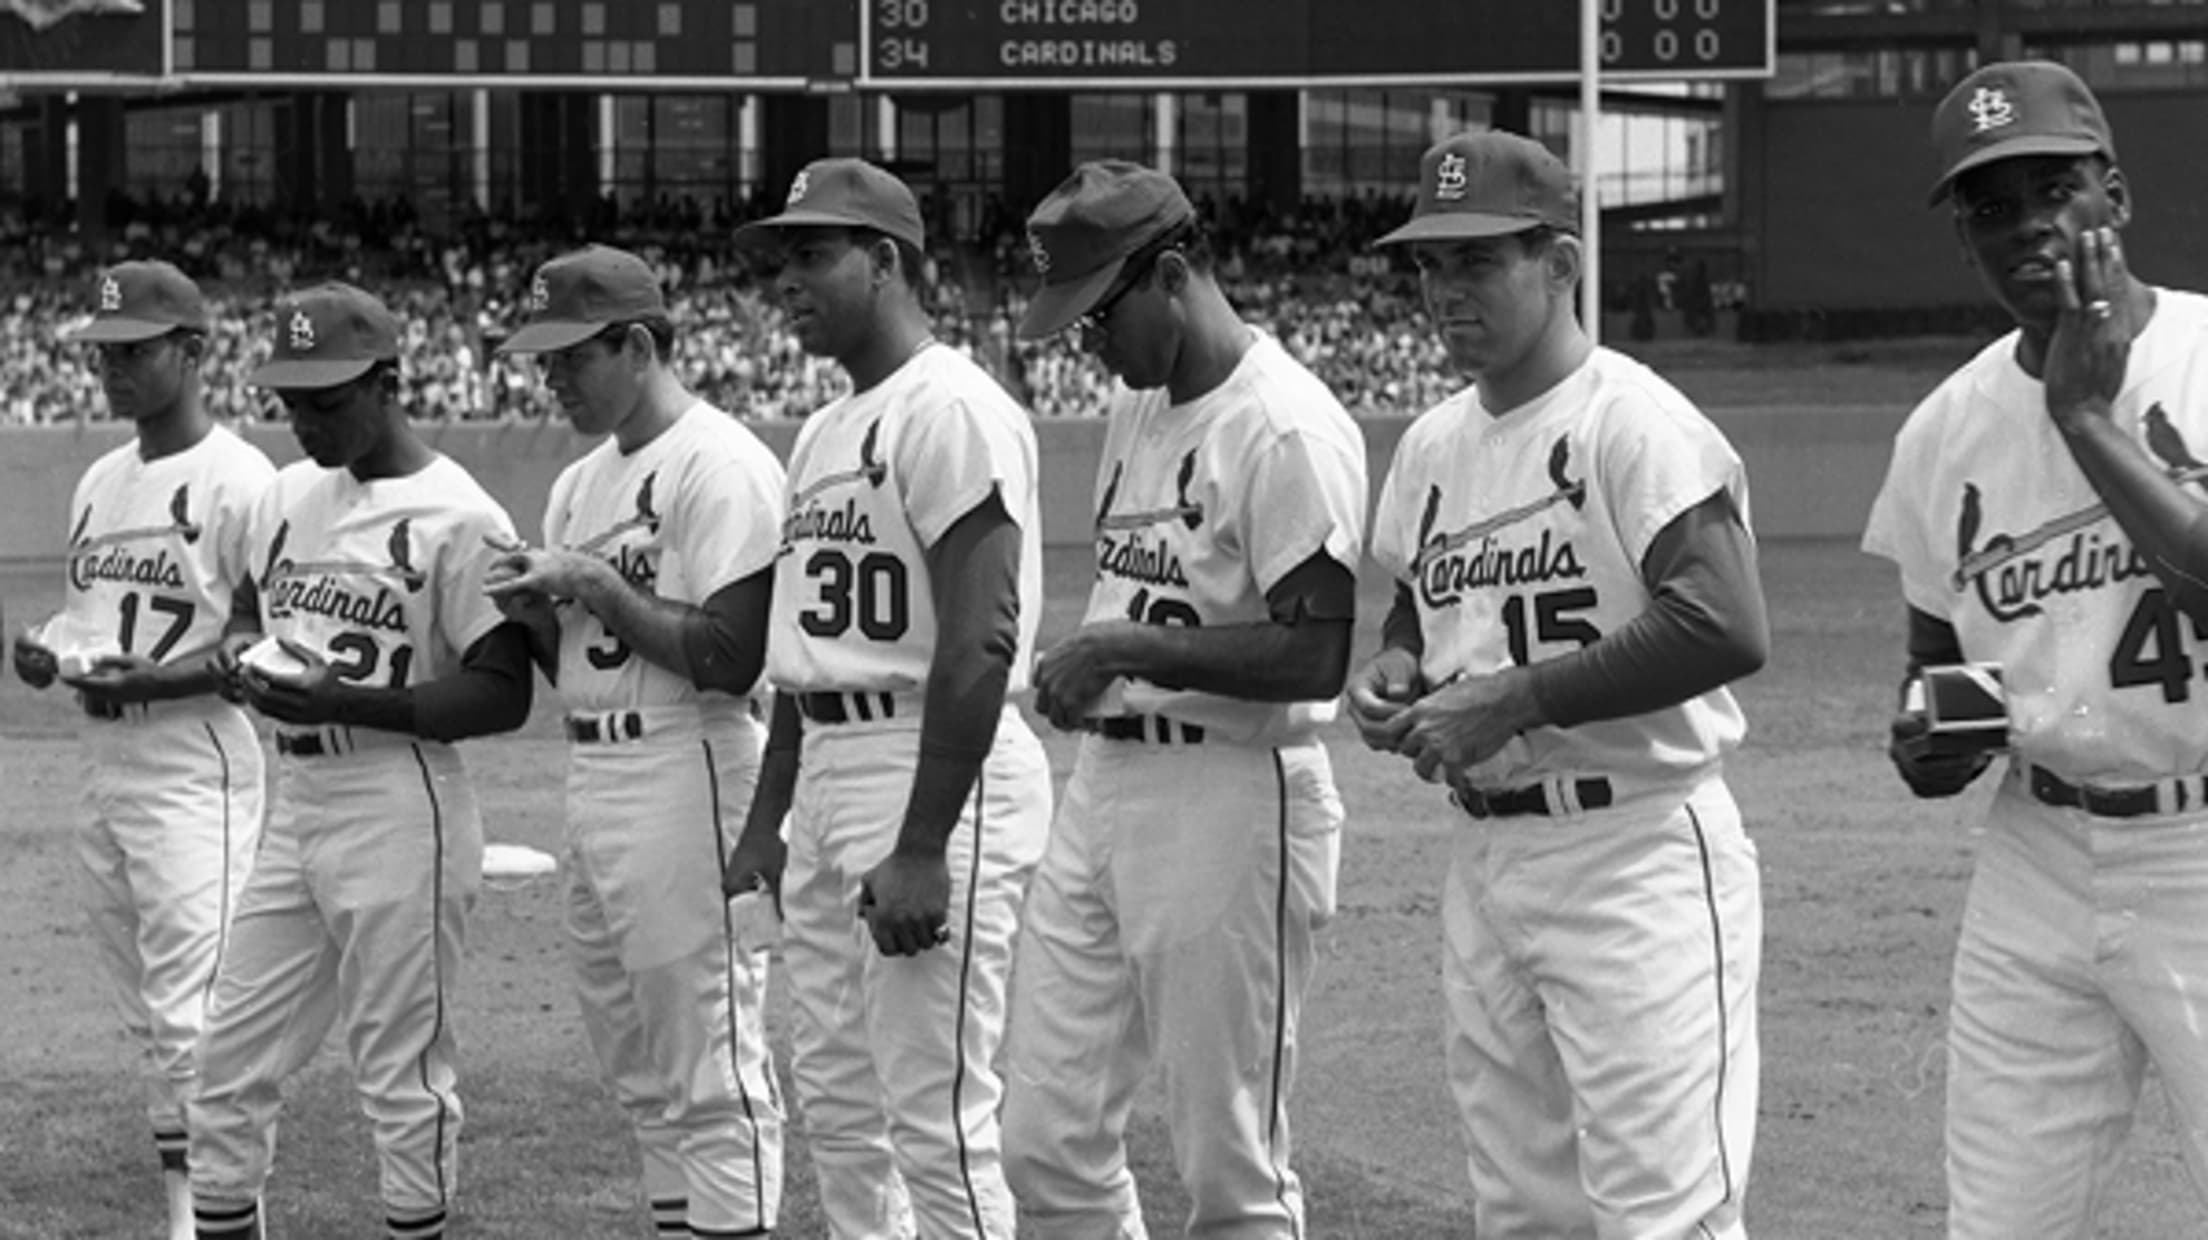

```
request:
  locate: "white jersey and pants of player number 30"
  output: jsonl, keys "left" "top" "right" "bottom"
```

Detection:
{"left": 766, "top": 337, "right": 1051, "bottom": 1240}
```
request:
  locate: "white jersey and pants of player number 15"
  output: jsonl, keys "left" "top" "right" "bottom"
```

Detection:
{"left": 1373, "top": 349, "right": 1762, "bottom": 1240}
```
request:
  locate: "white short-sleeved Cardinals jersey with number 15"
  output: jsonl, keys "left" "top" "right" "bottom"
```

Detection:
{"left": 1373, "top": 349, "right": 1749, "bottom": 788}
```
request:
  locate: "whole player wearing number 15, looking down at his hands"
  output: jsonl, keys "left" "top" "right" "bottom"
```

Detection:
{"left": 1349, "top": 132, "right": 1769, "bottom": 1240}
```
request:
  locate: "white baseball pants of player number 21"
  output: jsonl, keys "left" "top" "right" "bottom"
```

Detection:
{"left": 190, "top": 726, "right": 484, "bottom": 1236}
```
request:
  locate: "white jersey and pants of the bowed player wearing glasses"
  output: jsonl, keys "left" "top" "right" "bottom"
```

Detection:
{"left": 1005, "top": 324, "right": 1367, "bottom": 1240}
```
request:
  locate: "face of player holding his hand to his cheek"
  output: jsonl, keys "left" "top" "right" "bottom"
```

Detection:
{"left": 1954, "top": 154, "right": 2131, "bottom": 324}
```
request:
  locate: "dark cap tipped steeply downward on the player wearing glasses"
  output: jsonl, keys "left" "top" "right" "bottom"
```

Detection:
{"left": 1020, "top": 159, "right": 1197, "bottom": 340}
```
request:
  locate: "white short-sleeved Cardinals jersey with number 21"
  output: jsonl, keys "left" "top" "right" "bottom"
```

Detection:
{"left": 256, "top": 457, "right": 514, "bottom": 688}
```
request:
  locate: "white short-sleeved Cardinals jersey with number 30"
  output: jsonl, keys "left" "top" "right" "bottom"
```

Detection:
{"left": 766, "top": 344, "right": 1042, "bottom": 693}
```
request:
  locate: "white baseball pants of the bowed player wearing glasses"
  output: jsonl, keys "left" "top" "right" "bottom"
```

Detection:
{"left": 1005, "top": 737, "right": 1342, "bottom": 1240}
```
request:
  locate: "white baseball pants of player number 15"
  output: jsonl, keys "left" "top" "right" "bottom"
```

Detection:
{"left": 1442, "top": 777, "right": 1762, "bottom": 1240}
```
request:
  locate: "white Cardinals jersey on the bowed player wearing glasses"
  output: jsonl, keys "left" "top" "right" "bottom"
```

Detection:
{"left": 1086, "top": 329, "right": 1367, "bottom": 744}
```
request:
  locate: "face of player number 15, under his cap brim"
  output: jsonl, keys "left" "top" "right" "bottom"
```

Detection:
{"left": 1411, "top": 234, "right": 1559, "bottom": 375}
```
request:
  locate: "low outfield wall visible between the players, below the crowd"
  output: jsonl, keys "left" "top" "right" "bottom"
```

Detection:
{"left": 0, "top": 408, "right": 1903, "bottom": 567}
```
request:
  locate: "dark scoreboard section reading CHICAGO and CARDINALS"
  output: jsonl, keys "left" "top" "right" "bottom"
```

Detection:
{"left": 859, "top": 0, "right": 1775, "bottom": 90}
